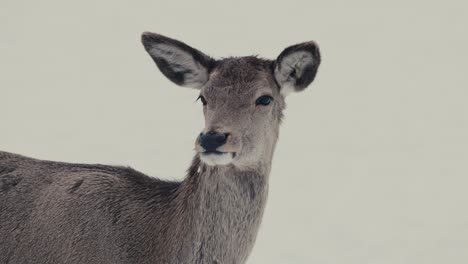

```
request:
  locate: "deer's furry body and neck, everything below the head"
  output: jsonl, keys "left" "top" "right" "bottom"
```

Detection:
{"left": 0, "top": 152, "right": 267, "bottom": 264}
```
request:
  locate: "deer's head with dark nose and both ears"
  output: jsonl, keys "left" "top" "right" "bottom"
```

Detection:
{"left": 142, "top": 32, "right": 320, "bottom": 168}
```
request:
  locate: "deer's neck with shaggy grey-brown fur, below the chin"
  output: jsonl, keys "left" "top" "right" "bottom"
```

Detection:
{"left": 176, "top": 157, "right": 270, "bottom": 263}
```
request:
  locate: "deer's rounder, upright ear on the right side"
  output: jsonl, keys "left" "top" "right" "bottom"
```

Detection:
{"left": 274, "top": 41, "right": 320, "bottom": 95}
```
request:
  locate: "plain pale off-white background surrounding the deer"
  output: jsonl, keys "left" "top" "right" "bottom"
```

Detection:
{"left": 0, "top": 0, "right": 468, "bottom": 264}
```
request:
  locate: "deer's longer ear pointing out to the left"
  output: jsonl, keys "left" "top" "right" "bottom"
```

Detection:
{"left": 141, "top": 32, "right": 215, "bottom": 89}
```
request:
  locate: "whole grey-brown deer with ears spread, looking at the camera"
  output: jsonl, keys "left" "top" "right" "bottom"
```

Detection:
{"left": 0, "top": 32, "right": 321, "bottom": 264}
